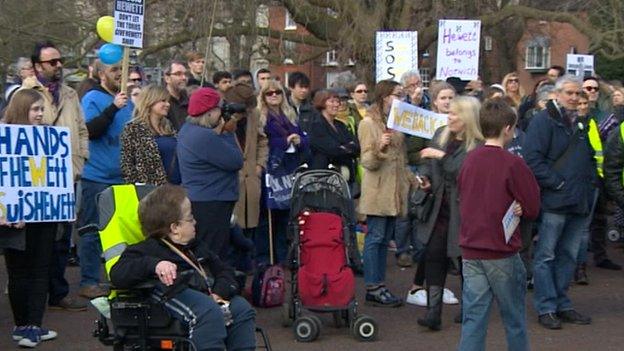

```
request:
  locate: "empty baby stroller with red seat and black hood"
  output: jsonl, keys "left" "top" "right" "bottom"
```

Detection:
{"left": 282, "top": 170, "right": 377, "bottom": 342}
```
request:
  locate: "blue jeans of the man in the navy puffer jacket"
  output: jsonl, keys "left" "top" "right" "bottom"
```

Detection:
{"left": 533, "top": 212, "right": 589, "bottom": 315}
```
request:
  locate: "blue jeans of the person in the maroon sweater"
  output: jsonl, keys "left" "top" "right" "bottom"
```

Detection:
{"left": 459, "top": 254, "right": 529, "bottom": 351}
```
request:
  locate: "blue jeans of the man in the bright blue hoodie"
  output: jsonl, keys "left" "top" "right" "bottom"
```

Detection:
{"left": 77, "top": 179, "right": 111, "bottom": 287}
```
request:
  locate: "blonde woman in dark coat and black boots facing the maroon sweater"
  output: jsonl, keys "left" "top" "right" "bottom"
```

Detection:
{"left": 416, "top": 96, "right": 483, "bottom": 330}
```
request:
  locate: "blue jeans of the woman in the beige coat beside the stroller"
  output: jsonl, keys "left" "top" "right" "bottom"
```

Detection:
{"left": 362, "top": 216, "right": 396, "bottom": 286}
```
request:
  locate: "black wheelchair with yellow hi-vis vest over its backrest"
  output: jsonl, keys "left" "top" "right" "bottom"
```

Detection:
{"left": 88, "top": 184, "right": 271, "bottom": 351}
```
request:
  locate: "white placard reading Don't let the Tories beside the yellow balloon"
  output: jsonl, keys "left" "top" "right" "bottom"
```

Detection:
{"left": 113, "top": 0, "right": 145, "bottom": 48}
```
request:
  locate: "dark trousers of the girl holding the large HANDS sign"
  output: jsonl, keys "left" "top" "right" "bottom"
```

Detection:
{"left": 4, "top": 223, "right": 57, "bottom": 326}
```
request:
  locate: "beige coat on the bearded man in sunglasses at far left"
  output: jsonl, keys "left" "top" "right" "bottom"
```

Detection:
{"left": 20, "top": 77, "right": 89, "bottom": 180}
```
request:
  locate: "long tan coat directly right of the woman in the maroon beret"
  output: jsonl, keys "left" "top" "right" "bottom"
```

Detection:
{"left": 234, "top": 110, "right": 269, "bottom": 229}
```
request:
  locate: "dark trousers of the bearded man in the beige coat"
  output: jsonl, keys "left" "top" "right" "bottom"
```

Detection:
{"left": 48, "top": 223, "right": 72, "bottom": 305}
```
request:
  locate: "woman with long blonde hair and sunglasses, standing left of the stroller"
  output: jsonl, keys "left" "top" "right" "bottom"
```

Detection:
{"left": 255, "top": 80, "right": 309, "bottom": 262}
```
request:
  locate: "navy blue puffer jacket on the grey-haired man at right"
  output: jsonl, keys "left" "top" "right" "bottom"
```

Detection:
{"left": 523, "top": 102, "right": 596, "bottom": 215}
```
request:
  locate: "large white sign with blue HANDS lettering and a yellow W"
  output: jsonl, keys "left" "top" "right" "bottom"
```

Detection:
{"left": 0, "top": 124, "right": 76, "bottom": 223}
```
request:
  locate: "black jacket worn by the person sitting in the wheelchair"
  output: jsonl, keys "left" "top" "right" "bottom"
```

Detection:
{"left": 110, "top": 238, "right": 239, "bottom": 300}
